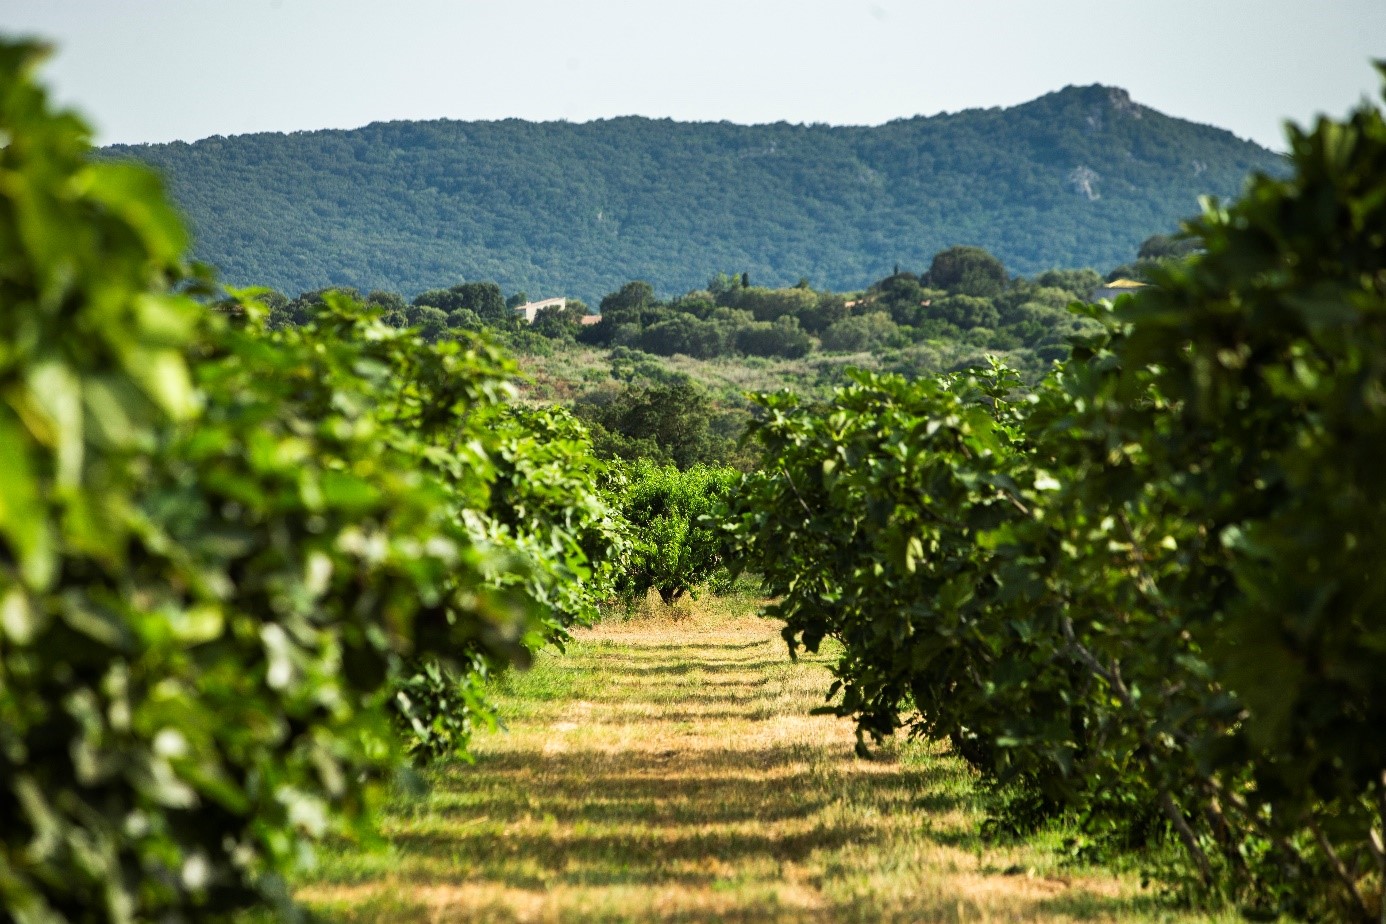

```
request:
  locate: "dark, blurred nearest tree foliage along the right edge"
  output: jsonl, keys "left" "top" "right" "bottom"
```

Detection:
{"left": 1075, "top": 72, "right": 1386, "bottom": 917}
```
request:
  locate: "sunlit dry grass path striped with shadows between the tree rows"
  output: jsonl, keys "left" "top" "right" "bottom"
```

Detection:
{"left": 299, "top": 601, "right": 1236, "bottom": 921}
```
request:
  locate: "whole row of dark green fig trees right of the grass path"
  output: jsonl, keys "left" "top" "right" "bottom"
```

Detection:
{"left": 737, "top": 70, "right": 1386, "bottom": 921}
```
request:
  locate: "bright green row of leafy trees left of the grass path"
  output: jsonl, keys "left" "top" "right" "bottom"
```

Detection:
{"left": 0, "top": 44, "right": 610, "bottom": 921}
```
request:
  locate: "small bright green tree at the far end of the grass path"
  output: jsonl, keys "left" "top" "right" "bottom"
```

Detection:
{"left": 617, "top": 460, "right": 742, "bottom": 604}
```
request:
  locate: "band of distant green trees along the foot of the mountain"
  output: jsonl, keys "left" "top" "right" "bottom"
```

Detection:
{"left": 249, "top": 249, "right": 1136, "bottom": 368}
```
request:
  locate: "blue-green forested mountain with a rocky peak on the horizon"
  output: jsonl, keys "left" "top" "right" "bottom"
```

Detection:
{"left": 104, "top": 86, "right": 1282, "bottom": 302}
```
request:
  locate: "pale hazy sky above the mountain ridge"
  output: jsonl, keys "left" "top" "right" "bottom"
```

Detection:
{"left": 10, "top": 0, "right": 1386, "bottom": 148}
